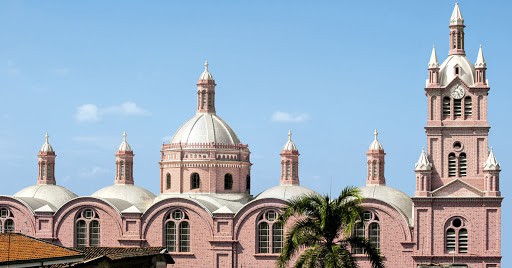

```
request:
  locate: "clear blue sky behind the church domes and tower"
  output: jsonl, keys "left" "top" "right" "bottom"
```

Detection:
{"left": 0, "top": 1, "right": 512, "bottom": 267}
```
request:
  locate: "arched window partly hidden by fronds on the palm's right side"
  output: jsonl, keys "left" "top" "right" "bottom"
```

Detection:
{"left": 352, "top": 211, "right": 380, "bottom": 254}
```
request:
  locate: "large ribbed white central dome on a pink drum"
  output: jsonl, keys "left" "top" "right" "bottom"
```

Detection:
{"left": 171, "top": 113, "right": 240, "bottom": 145}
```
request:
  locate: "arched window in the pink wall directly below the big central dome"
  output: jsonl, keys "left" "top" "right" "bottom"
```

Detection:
{"left": 164, "top": 209, "right": 190, "bottom": 252}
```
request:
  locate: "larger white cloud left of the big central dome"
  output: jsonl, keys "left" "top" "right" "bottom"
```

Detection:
{"left": 75, "top": 101, "right": 150, "bottom": 122}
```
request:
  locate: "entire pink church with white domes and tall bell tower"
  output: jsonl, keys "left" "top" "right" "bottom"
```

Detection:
{"left": 0, "top": 5, "right": 502, "bottom": 268}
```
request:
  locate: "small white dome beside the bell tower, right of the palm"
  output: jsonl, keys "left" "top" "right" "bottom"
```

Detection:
{"left": 359, "top": 185, "right": 413, "bottom": 224}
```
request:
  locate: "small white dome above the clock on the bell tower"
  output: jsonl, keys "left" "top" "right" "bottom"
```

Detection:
{"left": 439, "top": 55, "right": 475, "bottom": 86}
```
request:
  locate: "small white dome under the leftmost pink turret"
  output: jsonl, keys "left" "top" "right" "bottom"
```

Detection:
{"left": 14, "top": 184, "right": 77, "bottom": 209}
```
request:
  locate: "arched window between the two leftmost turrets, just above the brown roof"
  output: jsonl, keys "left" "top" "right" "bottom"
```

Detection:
{"left": 75, "top": 208, "right": 100, "bottom": 247}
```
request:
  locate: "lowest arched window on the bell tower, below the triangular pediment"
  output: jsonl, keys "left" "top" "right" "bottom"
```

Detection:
{"left": 445, "top": 217, "right": 469, "bottom": 253}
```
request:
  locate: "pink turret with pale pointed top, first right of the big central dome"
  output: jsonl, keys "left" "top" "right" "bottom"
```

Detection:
{"left": 281, "top": 130, "right": 300, "bottom": 185}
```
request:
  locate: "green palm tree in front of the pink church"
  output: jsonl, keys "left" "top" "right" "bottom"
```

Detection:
{"left": 277, "top": 187, "right": 384, "bottom": 268}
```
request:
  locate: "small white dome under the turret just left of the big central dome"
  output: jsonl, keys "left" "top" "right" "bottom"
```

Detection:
{"left": 91, "top": 185, "right": 156, "bottom": 210}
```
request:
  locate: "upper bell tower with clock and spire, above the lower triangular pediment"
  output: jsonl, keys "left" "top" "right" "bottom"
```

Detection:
{"left": 417, "top": 4, "right": 490, "bottom": 195}
